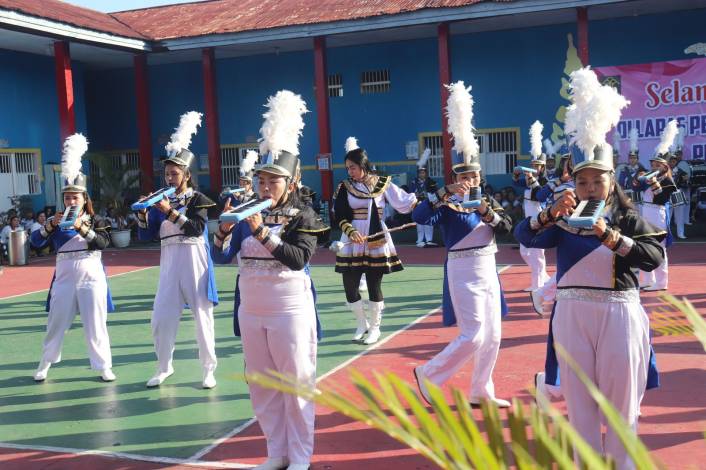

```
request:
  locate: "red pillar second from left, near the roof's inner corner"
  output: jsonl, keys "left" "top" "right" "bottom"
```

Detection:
{"left": 133, "top": 54, "right": 154, "bottom": 194}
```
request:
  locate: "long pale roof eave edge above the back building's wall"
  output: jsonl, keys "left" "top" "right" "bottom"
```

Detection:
{"left": 159, "top": 0, "right": 629, "bottom": 51}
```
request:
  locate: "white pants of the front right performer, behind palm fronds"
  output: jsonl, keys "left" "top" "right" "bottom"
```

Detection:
{"left": 552, "top": 299, "right": 650, "bottom": 469}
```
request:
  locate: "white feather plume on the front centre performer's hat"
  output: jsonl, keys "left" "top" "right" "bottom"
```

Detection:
{"left": 260, "top": 90, "right": 309, "bottom": 158}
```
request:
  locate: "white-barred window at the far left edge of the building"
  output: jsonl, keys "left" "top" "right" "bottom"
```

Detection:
{"left": 0, "top": 149, "right": 42, "bottom": 210}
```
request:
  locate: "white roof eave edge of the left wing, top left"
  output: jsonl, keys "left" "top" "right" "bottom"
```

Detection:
{"left": 0, "top": 9, "right": 152, "bottom": 52}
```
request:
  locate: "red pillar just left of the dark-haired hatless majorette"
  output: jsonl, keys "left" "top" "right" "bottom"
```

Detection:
{"left": 314, "top": 36, "right": 333, "bottom": 201}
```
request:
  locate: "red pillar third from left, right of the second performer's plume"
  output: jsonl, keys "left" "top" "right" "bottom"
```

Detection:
{"left": 202, "top": 47, "right": 223, "bottom": 191}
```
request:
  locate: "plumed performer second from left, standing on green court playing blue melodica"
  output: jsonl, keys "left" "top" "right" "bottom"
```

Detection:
{"left": 137, "top": 111, "right": 218, "bottom": 388}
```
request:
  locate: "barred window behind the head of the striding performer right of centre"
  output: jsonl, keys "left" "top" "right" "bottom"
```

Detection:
{"left": 412, "top": 128, "right": 520, "bottom": 178}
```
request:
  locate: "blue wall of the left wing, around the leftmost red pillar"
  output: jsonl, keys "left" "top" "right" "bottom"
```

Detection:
{"left": 0, "top": 49, "right": 86, "bottom": 210}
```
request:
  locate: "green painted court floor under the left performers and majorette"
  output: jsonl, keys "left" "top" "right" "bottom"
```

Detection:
{"left": 0, "top": 266, "right": 443, "bottom": 459}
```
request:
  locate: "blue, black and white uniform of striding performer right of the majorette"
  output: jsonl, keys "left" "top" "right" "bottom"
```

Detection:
{"left": 412, "top": 180, "right": 512, "bottom": 405}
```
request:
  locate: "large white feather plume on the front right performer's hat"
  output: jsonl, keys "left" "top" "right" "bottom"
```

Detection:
{"left": 564, "top": 67, "right": 630, "bottom": 160}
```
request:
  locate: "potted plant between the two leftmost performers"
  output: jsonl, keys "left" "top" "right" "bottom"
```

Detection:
{"left": 89, "top": 155, "right": 140, "bottom": 248}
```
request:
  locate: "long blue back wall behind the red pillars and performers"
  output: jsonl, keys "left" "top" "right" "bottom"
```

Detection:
{"left": 80, "top": 9, "right": 706, "bottom": 198}
